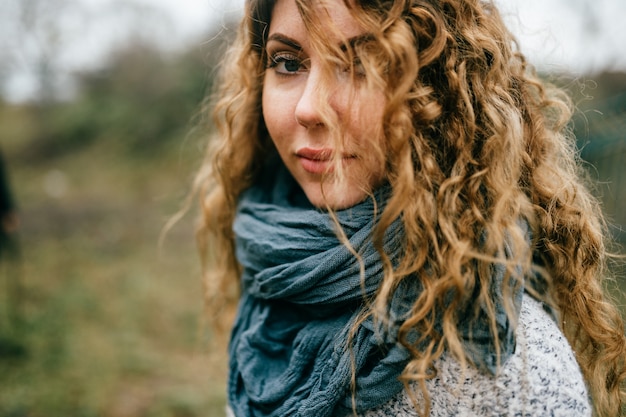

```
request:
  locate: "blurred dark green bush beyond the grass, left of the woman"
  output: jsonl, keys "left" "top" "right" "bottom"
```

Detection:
{"left": 12, "top": 42, "right": 211, "bottom": 159}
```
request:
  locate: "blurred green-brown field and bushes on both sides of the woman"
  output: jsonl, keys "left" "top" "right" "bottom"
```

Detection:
{"left": 0, "top": 0, "right": 626, "bottom": 417}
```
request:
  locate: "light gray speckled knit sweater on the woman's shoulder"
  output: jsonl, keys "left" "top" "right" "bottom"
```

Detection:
{"left": 352, "top": 295, "right": 592, "bottom": 417}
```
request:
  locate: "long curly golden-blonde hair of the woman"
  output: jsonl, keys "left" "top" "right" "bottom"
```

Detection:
{"left": 196, "top": 0, "right": 626, "bottom": 416}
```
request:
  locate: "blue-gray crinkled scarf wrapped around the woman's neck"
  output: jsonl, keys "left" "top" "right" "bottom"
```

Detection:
{"left": 228, "top": 165, "right": 521, "bottom": 417}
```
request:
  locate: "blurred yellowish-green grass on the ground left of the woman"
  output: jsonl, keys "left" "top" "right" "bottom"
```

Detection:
{"left": 0, "top": 109, "right": 226, "bottom": 417}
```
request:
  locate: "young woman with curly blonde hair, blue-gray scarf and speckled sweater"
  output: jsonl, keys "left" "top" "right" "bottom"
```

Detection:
{"left": 198, "top": 0, "right": 626, "bottom": 417}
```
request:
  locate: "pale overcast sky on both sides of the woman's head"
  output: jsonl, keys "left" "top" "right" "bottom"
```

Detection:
{"left": 0, "top": 0, "right": 626, "bottom": 99}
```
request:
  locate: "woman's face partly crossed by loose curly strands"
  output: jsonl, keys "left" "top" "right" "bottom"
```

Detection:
{"left": 263, "top": 0, "right": 385, "bottom": 209}
